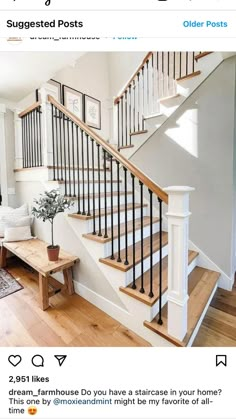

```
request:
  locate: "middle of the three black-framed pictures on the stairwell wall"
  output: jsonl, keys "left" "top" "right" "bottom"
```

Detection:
{"left": 62, "top": 85, "right": 84, "bottom": 121}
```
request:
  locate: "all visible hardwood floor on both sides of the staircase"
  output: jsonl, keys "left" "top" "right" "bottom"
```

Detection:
{"left": 0, "top": 260, "right": 236, "bottom": 347}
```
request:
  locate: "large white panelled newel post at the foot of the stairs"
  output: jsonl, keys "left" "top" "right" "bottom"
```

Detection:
{"left": 164, "top": 187, "right": 194, "bottom": 341}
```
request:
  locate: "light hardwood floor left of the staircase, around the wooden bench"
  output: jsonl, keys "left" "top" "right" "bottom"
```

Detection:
{"left": 0, "top": 260, "right": 150, "bottom": 347}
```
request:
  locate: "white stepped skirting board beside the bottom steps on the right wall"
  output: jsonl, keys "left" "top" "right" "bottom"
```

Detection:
{"left": 189, "top": 241, "right": 234, "bottom": 291}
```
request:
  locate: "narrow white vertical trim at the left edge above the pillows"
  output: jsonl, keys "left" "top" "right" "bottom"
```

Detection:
{"left": 0, "top": 104, "right": 8, "bottom": 206}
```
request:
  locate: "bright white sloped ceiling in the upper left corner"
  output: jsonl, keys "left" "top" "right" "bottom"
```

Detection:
{"left": 0, "top": 51, "right": 85, "bottom": 102}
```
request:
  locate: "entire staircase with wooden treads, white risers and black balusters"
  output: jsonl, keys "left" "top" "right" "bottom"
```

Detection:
{"left": 15, "top": 53, "right": 224, "bottom": 346}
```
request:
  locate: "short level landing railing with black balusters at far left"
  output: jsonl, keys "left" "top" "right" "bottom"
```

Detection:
{"left": 19, "top": 101, "right": 43, "bottom": 168}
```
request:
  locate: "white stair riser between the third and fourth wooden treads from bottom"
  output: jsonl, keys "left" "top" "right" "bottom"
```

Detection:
{"left": 101, "top": 223, "right": 159, "bottom": 258}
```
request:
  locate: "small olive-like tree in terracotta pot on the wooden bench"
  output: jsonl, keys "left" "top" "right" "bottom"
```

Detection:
{"left": 32, "top": 190, "right": 74, "bottom": 261}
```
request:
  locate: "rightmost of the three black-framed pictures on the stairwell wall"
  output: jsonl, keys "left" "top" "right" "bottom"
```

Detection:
{"left": 84, "top": 95, "right": 101, "bottom": 130}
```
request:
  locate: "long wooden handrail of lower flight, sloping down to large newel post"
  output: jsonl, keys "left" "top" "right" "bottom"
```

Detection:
{"left": 48, "top": 95, "right": 168, "bottom": 204}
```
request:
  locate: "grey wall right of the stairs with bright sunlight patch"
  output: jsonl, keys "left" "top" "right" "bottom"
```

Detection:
{"left": 131, "top": 58, "right": 236, "bottom": 277}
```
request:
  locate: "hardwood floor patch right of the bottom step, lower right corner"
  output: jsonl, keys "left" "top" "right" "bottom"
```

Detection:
{"left": 193, "top": 282, "right": 236, "bottom": 347}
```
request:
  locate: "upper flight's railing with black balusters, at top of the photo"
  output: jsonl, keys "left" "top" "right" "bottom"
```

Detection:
{"left": 114, "top": 51, "right": 202, "bottom": 150}
